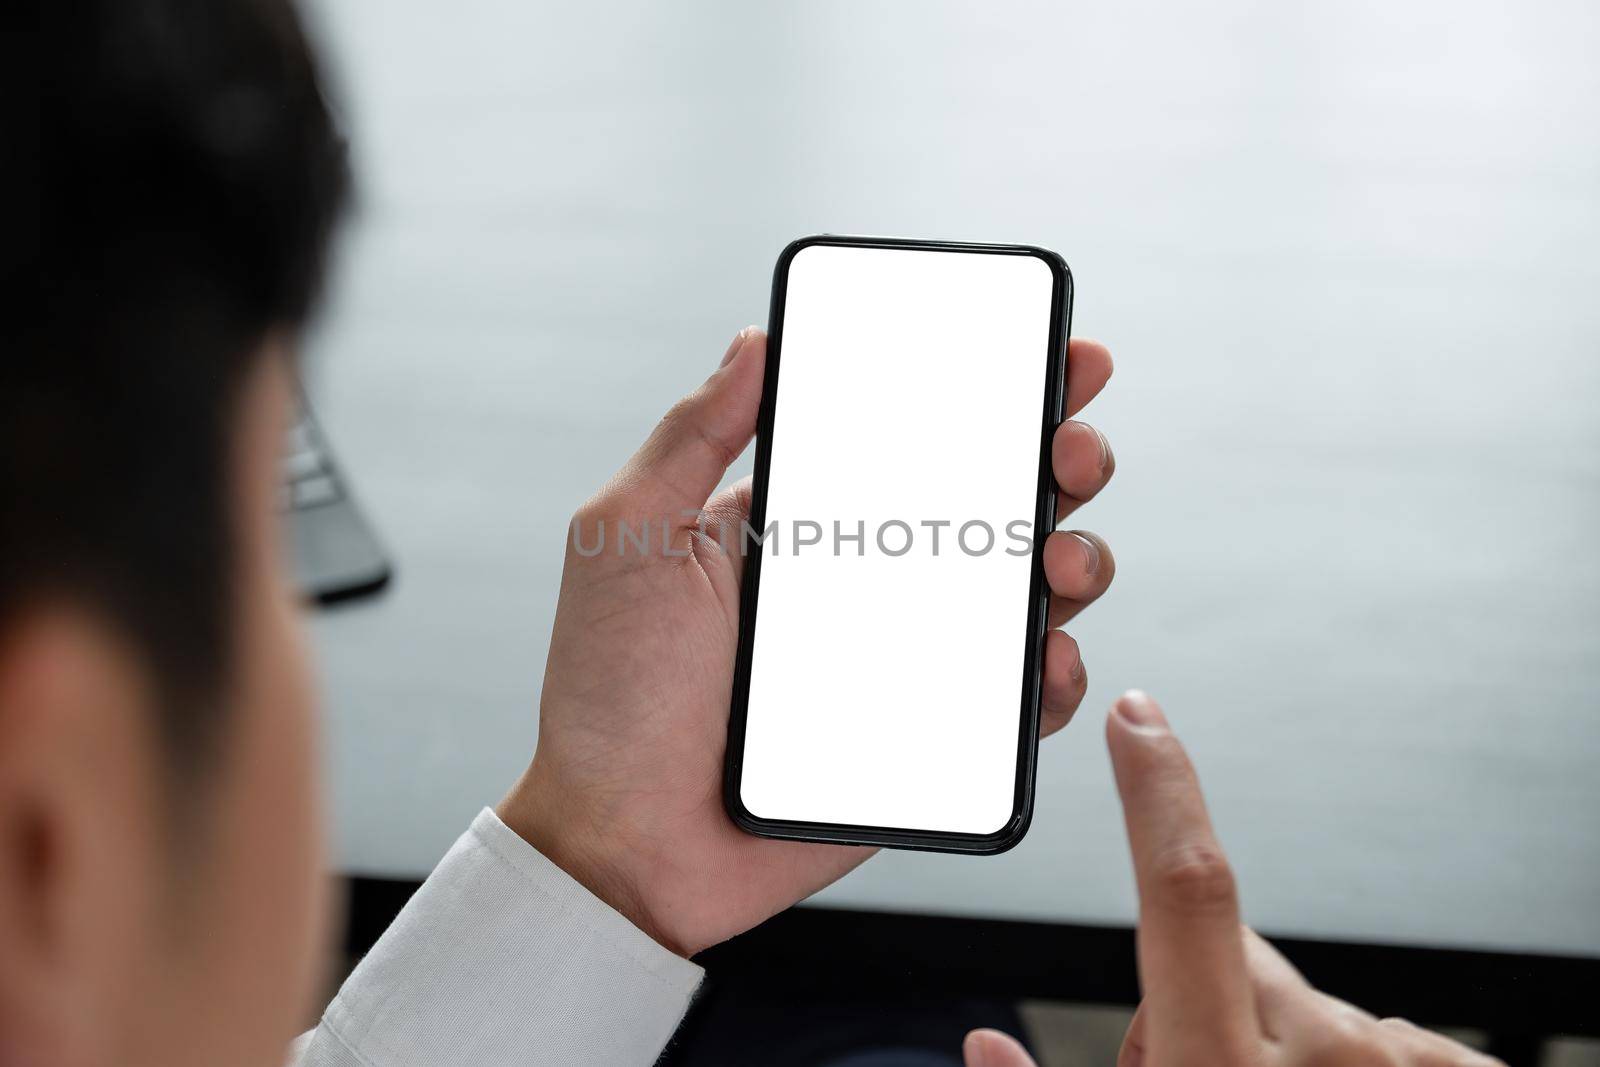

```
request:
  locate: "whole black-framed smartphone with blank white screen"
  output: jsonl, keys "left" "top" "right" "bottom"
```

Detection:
{"left": 723, "top": 235, "right": 1072, "bottom": 853}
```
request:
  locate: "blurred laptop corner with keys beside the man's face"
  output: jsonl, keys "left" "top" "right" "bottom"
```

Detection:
{"left": 282, "top": 400, "right": 394, "bottom": 603}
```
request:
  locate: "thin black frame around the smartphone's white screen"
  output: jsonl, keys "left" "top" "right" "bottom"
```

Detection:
{"left": 723, "top": 234, "right": 1072, "bottom": 856}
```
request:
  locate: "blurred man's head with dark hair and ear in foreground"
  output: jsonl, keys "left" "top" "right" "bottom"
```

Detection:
{"left": 0, "top": 0, "right": 346, "bottom": 1064}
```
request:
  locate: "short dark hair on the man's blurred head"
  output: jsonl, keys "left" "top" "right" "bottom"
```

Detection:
{"left": 0, "top": 0, "right": 347, "bottom": 758}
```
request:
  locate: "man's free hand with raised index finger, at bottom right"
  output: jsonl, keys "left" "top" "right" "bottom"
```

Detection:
{"left": 963, "top": 693, "right": 1499, "bottom": 1067}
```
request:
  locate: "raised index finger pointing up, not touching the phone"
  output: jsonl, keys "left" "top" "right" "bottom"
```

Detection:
{"left": 1106, "top": 691, "right": 1258, "bottom": 1062}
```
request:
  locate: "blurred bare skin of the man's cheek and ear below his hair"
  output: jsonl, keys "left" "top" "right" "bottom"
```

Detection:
{"left": 0, "top": 351, "right": 328, "bottom": 1067}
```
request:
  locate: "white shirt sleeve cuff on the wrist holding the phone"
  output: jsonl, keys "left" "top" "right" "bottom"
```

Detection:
{"left": 290, "top": 808, "right": 704, "bottom": 1067}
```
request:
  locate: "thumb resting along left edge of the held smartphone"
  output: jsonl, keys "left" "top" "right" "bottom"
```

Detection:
{"left": 605, "top": 326, "right": 766, "bottom": 525}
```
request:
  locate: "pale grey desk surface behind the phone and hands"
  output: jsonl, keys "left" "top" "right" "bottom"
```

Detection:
{"left": 300, "top": 0, "right": 1600, "bottom": 955}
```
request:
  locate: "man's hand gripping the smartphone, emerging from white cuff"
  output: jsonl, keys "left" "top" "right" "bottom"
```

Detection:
{"left": 499, "top": 328, "right": 1114, "bottom": 955}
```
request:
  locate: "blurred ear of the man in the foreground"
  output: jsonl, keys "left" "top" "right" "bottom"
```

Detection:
{"left": 0, "top": 606, "right": 163, "bottom": 1064}
